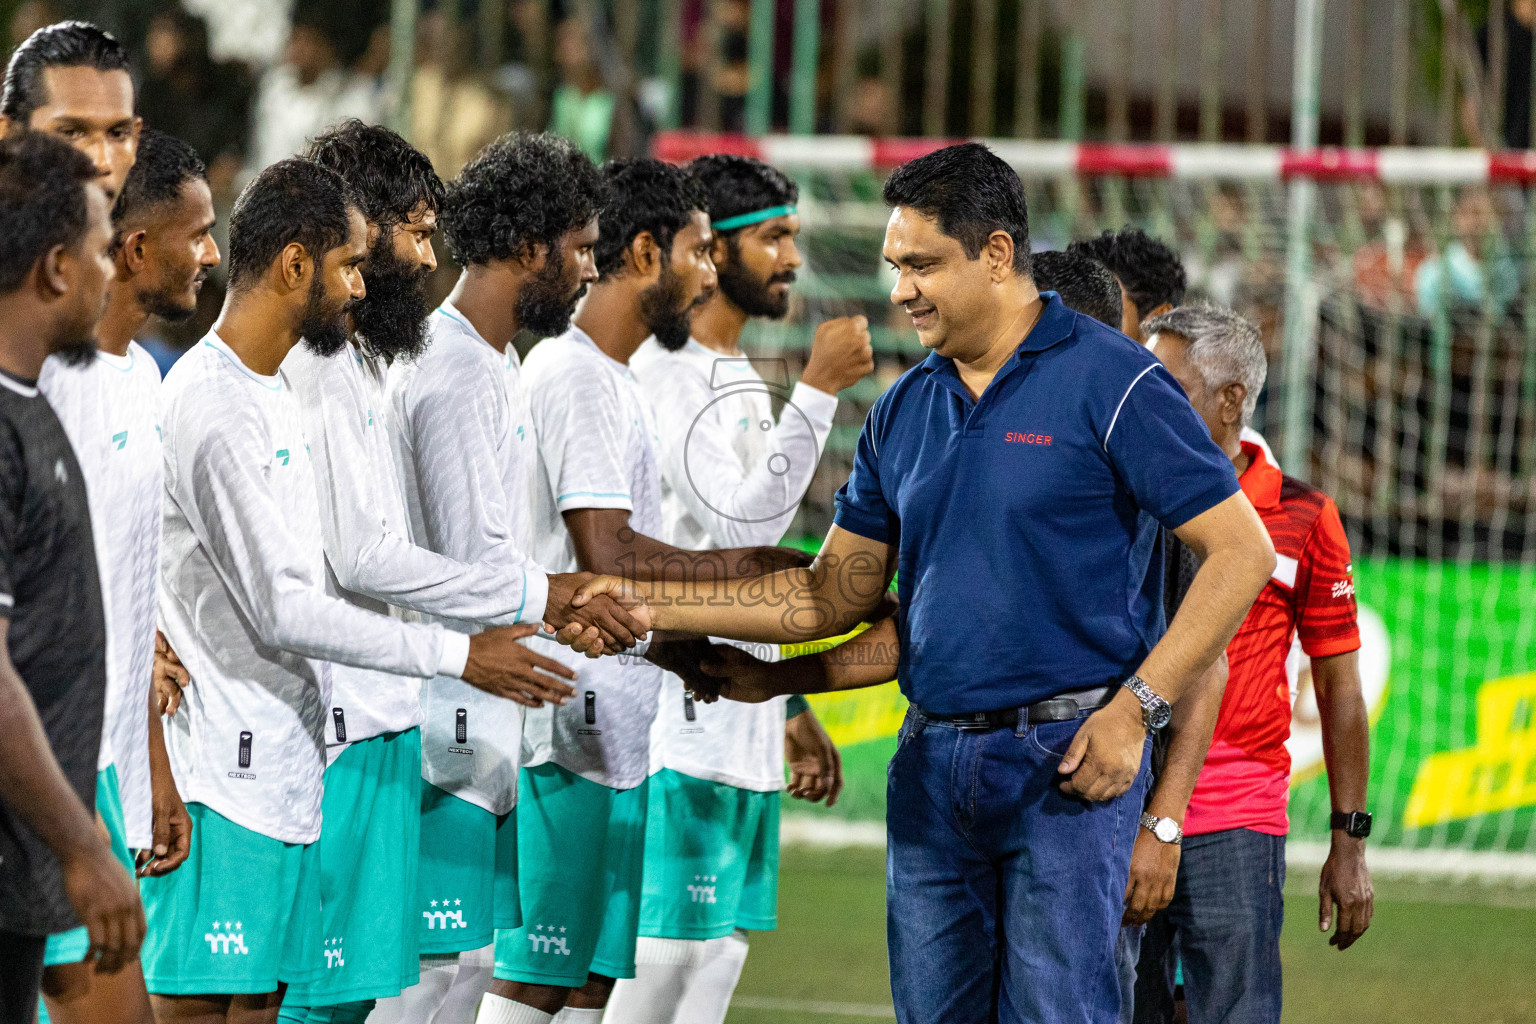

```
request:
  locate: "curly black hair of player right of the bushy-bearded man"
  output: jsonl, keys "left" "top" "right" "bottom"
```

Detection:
{"left": 439, "top": 132, "right": 608, "bottom": 267}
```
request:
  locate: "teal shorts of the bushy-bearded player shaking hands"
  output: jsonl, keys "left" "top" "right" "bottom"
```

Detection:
{"left": 284, "top": 729, "right": 422, "bottom": 1006}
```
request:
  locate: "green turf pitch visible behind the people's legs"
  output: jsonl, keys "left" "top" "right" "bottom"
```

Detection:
{"left": 727, "top": 847, "right": 1536, "bottom": 1024}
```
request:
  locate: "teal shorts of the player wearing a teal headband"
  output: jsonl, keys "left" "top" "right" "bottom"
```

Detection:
{"left": 641, "top": 769, "right": 782, "bottom": 940}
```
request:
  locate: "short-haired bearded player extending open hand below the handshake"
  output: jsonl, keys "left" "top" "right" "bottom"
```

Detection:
{"left": 141, "top": 160, "right": 565, "bottom": 1021}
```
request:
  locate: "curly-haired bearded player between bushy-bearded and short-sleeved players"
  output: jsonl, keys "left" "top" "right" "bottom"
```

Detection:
{"left": 372, "top": 134, "right": 648, "bottom": 1024}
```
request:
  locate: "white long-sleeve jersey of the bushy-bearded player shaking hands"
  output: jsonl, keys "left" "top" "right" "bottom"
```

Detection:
{"left": 283, "top": 345, "right": 544, "bottom": 760}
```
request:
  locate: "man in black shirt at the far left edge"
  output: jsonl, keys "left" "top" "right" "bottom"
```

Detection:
{"left": 0, "top": 134, "right": 144, "bottom": 1024}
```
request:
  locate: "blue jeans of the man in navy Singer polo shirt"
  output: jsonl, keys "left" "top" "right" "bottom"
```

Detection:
{"left": 886, "top": 711, "right": 1150, "bottom": 1024}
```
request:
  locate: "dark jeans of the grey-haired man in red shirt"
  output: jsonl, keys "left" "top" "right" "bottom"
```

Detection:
{"left": 1135, "top": 829, "right": 1286, "bottom": 1024}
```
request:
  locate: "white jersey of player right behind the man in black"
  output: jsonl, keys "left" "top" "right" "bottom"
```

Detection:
{"left": 37, "top": 342, "right": 164, "bottom": 849}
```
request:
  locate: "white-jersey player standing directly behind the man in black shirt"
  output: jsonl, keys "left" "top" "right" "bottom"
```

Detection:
{"left": 38, "top": 130, "right": 220, "bottom": 1024}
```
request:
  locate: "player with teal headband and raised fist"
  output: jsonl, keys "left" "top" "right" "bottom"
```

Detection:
{"left": 605, "top": 155, "right": 874, "bottom": 1024}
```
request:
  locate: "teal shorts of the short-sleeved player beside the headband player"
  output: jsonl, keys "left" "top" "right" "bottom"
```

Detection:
{"left": 496, "top": 763, "right": 648, "bottom": 987}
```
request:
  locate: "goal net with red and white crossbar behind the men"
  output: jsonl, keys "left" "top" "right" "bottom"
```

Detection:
{"left": 656, "top": 135, "right": 1536, "bottom": 878}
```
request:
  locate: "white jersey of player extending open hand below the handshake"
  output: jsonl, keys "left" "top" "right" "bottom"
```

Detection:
{"left": 160, "top": 332, "right": 468, "bottom": 843}
